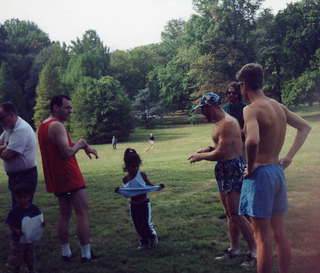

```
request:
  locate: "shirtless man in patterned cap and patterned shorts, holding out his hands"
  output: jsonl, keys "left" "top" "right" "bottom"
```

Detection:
{"left": 188, "top": 93, "right": 256, "bottom": 267}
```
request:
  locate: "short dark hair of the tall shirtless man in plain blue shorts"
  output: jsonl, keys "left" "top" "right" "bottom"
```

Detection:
{"left": 237, "top": 63, "right": 263, "bottom": 91}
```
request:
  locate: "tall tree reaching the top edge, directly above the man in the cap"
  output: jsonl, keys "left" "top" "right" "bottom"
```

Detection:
{"left": 196, "top": 0, "right": 262, "bottom": 90}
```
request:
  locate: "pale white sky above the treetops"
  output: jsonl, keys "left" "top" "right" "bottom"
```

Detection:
{"left": 0, "top": 0, "right": 294, "bottom": 51}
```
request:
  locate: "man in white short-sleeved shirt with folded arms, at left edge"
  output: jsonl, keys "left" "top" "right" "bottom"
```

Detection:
{"left": 0, "top": 102, "right": 38, "bottom": 206}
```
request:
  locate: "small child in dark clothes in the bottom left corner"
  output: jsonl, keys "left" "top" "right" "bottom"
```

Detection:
{"left": 6, "top": 184, "right": 44, "bottom": 273}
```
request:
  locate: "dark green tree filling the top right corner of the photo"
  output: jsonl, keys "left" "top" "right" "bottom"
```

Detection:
{"left": 256, "top": 0, "right": 320, "bottom": 101}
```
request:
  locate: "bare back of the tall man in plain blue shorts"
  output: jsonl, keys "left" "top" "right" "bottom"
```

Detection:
{"left": 244, "top": 97, "right": 287, "bottom": 166}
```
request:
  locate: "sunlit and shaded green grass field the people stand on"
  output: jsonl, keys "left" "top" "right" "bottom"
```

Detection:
{"left": 0, "top": 115, "right": 320, "bottom": 273}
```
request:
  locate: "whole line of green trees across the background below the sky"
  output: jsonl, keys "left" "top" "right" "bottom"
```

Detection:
{"left": 0, "top": 0, "right": 320, "bottom": 143}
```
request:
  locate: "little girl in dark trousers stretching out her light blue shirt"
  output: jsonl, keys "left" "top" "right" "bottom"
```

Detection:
{"left": 115, "top": 148, "right": 164, "bottom": 249}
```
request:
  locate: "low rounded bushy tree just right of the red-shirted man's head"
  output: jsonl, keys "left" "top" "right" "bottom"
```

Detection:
{"left": 72, "top": 76, "right": 133, "bottom": 143}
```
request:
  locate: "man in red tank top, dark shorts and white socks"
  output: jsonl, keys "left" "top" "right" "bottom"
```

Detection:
{"left": 38, "top": 95, "right": 98, "bottom": 262}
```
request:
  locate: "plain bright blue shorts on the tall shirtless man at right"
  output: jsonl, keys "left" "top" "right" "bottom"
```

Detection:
{"left": 239, "top": 164, "right": 288, "bottom": 218}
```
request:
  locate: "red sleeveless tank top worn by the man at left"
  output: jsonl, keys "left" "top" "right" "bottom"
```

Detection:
{"left": 38, "top": 118, "right": 85, "bottom": 194}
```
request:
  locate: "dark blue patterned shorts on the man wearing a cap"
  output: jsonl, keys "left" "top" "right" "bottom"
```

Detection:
{"left": 214, "top": 157, "right": 244, "bottom": 194}
